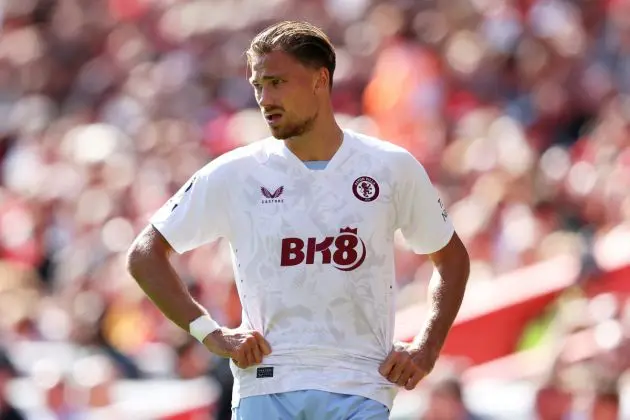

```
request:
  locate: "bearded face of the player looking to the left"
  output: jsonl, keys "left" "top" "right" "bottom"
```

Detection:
{"left": 250, "top": 51, "right": 327, "bottom": 139}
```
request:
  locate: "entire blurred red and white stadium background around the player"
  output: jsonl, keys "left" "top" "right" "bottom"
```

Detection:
{"left": 0, "top": 0, "right": 630, "bottom": 420}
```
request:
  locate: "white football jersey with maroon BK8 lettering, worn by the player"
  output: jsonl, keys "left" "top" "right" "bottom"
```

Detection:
{"left": 151, "top": 130, "right": 453, "bottom": 409}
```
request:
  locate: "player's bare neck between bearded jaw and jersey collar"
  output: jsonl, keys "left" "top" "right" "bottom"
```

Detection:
{"left": 284, "top": 121, "right": 343, "bottom": 161}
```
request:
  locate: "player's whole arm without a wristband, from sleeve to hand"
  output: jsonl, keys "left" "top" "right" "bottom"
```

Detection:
{"left": 379, "top": 153, "right": 470, "bottom": 389}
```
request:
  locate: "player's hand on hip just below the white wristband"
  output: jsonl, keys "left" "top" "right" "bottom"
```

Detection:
{"left": 203, "top": 328, "right": 271, "bottom": 369}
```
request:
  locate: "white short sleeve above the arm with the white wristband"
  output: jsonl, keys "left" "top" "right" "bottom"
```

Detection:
{"left": 150, "top": 161, "right": 229, "bottom": 254}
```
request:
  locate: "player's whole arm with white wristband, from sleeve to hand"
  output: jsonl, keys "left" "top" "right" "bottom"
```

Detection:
{"left": 127, "top": 159, "right": 271, "bottom": 368}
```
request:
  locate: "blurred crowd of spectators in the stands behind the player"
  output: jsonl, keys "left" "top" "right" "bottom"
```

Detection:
{"left": 0, "top": 0, "right": 630, "bottom": 418}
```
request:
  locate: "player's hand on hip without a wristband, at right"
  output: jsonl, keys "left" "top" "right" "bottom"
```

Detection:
{"left": 378, "top": 343, "right": 435, "bottom": 391}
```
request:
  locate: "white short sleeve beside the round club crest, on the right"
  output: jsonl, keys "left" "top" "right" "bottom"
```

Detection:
{"left": 396, "top": 151, "right": 454, "bottom": 254}
